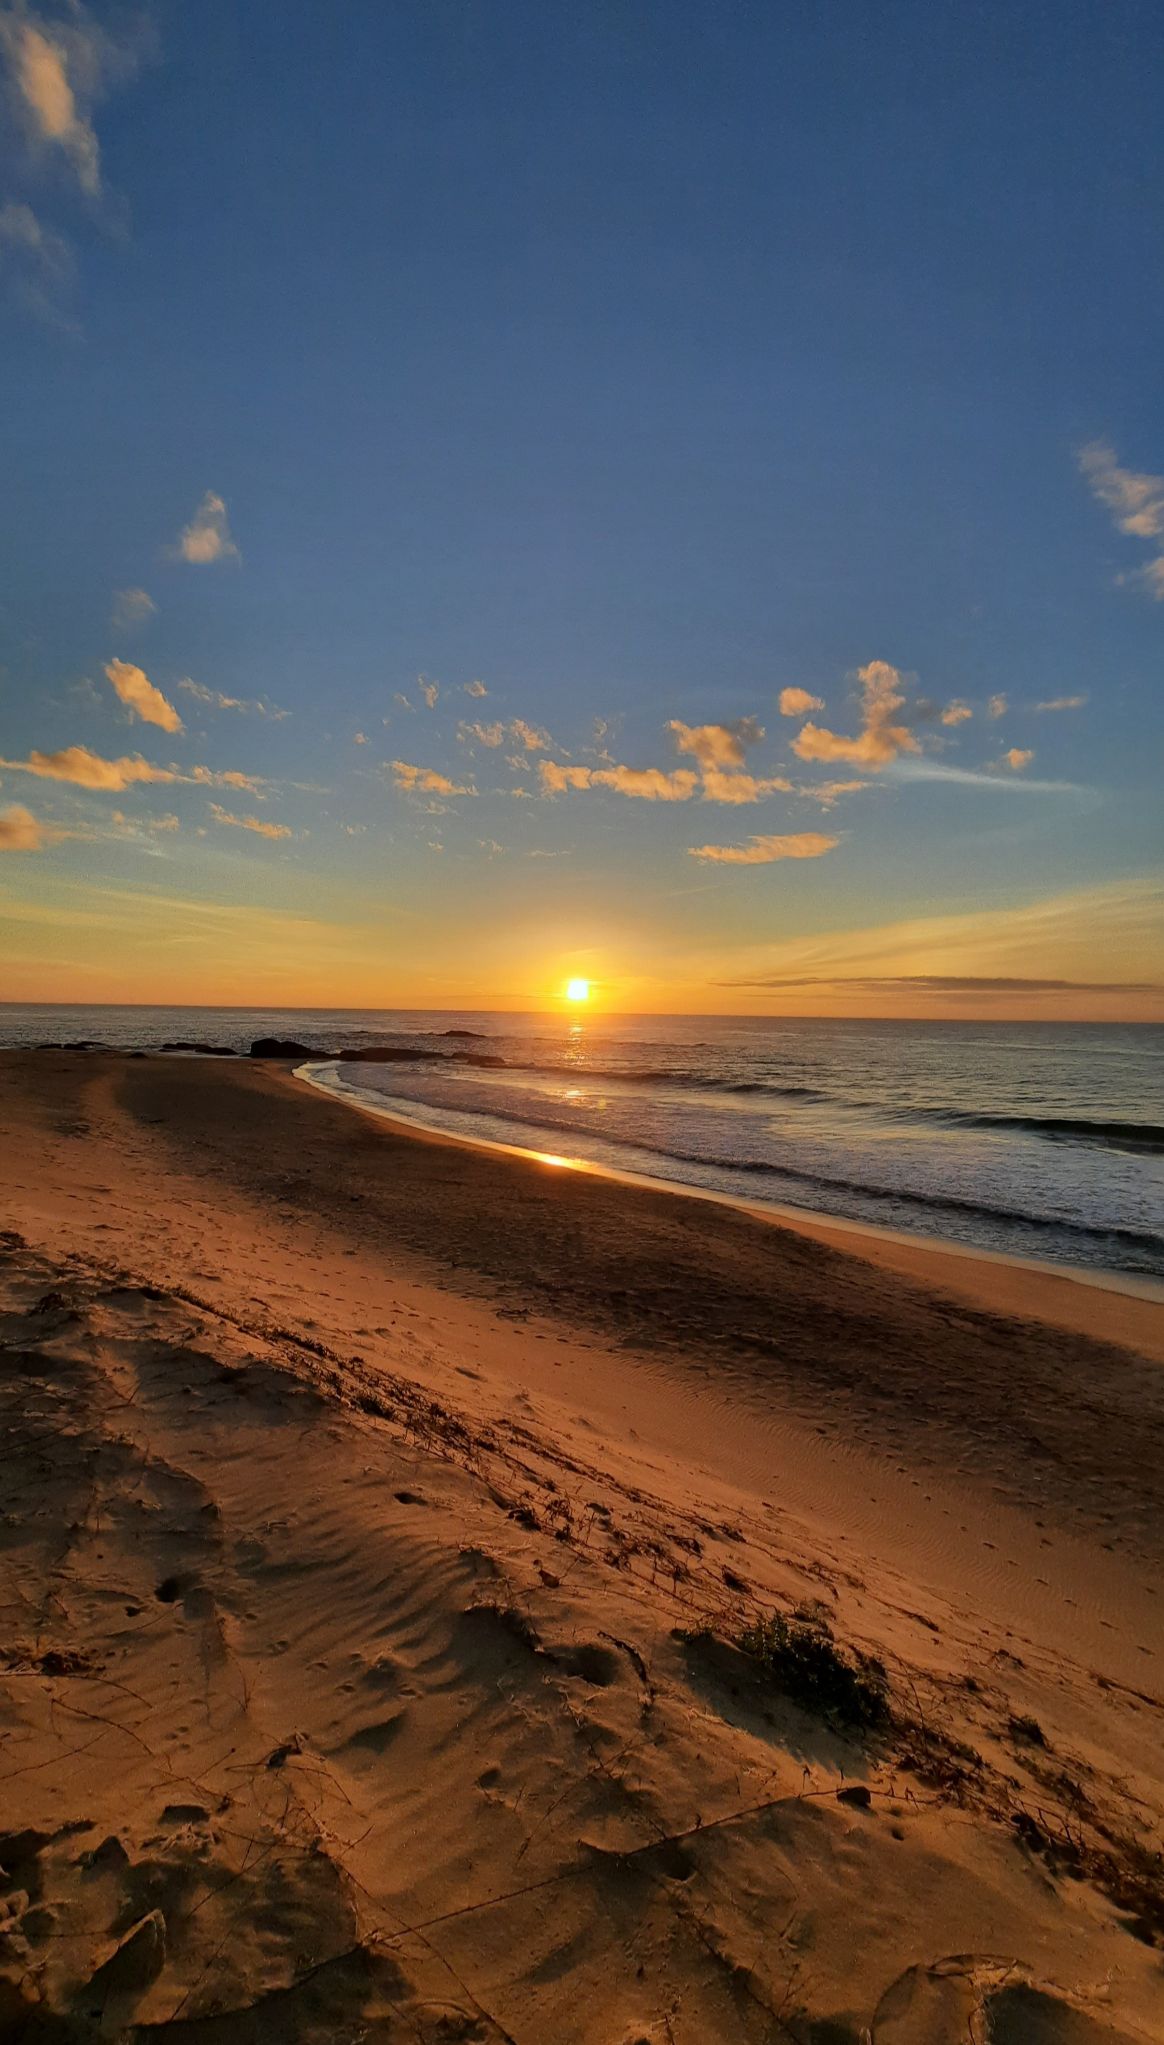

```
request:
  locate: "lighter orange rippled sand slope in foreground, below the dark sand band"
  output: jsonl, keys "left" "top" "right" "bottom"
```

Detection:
{"left": 0, "top": 1074, "right": 1164, "bottom": 2045}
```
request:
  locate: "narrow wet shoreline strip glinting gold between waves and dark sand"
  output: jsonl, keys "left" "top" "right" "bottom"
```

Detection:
{"left": 290, "top": 1061, "right": 1164, "bottom": 1316}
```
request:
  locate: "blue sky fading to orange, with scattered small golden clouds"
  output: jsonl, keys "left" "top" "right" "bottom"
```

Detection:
{"left": 0, "top": 0, "right": 1164, "bottom": 1020}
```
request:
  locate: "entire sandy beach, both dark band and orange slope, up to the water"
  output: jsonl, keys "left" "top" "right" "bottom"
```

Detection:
{"left": 0, "top": 1053, "right": 1164, "bottom": 2045}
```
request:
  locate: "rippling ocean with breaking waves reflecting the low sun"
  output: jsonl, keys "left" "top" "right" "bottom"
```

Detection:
{"left": 0, "top": 1004, "right": 1164, "bottom": 1280}
